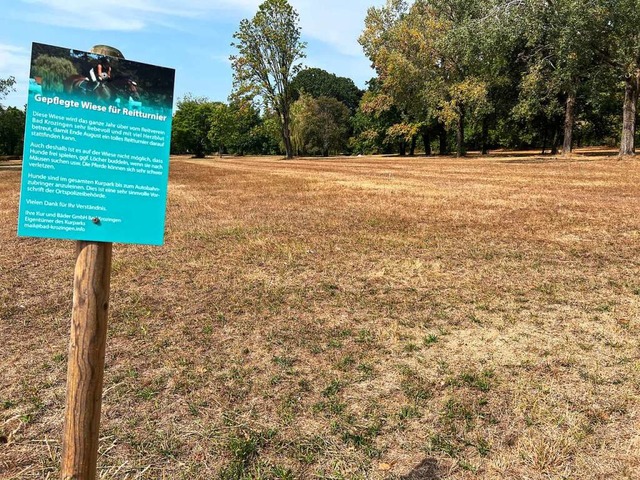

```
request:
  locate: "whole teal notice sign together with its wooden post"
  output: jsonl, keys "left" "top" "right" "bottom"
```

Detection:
{"left": 18, "top": 43, "right": 175, "bottom": 480}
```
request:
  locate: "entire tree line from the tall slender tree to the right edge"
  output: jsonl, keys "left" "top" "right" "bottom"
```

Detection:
{"left": 171, "top": 0, "right": 640, "bottom": 158}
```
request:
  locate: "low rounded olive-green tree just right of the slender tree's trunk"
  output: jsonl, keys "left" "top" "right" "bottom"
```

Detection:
{"left": 291, "top": 93, "right": 349, "bottom": 157}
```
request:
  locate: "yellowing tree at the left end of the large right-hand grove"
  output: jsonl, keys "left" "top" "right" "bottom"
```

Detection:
{"left": 360, "top": 0, "right": 488, "bottom": 155}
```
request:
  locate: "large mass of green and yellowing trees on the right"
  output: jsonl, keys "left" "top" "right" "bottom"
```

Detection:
{"left": 356, "top": 0, "right": 640, "bottom": 155}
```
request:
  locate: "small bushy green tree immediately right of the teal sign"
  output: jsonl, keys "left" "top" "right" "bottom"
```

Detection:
{"left": 171, "top": 95, "right": 220, "bottom": 158}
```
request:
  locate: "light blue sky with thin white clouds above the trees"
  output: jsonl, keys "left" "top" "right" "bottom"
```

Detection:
{"left": 0, "top": 0, "right": 385, "bottom": 107}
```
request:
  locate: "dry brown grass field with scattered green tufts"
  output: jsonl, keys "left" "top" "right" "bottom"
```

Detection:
{"left": 0, "top": 150, "right": 640, "bottom": 480}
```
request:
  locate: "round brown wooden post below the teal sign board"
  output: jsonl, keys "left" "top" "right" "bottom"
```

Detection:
{"left": 61, "top": 241, "right": 112, "bottom": 480}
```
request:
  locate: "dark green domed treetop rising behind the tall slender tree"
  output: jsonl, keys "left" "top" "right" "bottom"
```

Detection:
{"left": 291, "top": 68, "right": 363, "bottom": 113}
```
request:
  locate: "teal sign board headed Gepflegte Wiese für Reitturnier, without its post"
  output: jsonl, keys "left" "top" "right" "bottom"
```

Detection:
{"left": 18, "top": 43, "right": 175, "bottom": 245}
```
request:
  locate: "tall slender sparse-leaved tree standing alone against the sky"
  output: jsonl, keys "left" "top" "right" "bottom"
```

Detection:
{"left": 230, "top": 0, "right": 305, "bottom": 158}
